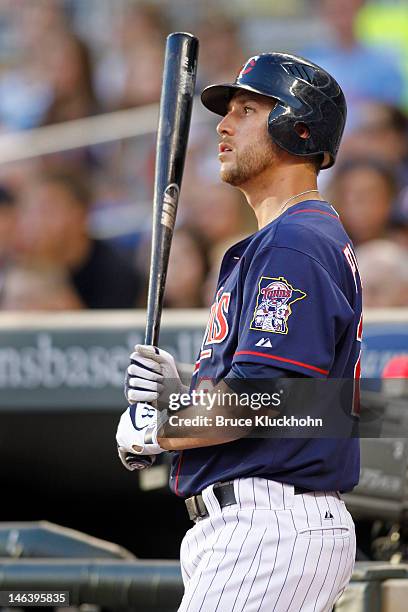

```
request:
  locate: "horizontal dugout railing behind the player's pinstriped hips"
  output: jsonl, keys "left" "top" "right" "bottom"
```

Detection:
{"left": 0, "top": 559, "right": 408, "bottom": 612}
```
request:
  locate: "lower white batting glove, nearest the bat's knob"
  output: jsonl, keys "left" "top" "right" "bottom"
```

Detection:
{"left": 116, "top": 403, "right": 164, "bottom": 459}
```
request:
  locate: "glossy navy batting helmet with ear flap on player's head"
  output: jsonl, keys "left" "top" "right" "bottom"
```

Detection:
{"left": 201, "top": 53, "right": 347, "bottom": 168}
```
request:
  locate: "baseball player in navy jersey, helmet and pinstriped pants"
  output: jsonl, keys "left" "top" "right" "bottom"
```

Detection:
{"left": 117, "top": 53, "right": 362, "bottom": 612}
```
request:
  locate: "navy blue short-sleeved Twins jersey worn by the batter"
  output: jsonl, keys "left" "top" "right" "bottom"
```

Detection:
{"left": 170, "top": 200, "right": 362, "bottom": 497}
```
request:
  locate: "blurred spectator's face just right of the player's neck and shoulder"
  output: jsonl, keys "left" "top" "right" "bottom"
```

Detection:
{"left": 330, "top": 159, "right": 395, "bottom": 245}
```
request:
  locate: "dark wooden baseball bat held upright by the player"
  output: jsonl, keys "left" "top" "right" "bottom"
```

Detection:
{"left": 126, "top": 32, "right": 198, "bottom": 470}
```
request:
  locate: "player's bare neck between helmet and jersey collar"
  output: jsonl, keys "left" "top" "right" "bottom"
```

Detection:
{"left": 240, "top": 164, "right": 324, "bottom": 229}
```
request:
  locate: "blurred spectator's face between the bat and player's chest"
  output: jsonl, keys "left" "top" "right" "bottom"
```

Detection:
{"left": 164, "top": 228, "right": 208, "bottom": 308}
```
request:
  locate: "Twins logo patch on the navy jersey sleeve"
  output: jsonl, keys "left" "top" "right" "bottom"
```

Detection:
{"left": 249, "top": 276, "right": 306, "bottom": 334}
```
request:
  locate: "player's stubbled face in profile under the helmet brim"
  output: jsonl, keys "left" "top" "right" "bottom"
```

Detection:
{"left": 217, "top": 92, "right": 277, "bottom": 186}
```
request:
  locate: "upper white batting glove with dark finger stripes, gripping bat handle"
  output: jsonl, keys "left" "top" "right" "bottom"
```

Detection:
{"left": 125, "top": 344, "right": 189, "bottom": 405}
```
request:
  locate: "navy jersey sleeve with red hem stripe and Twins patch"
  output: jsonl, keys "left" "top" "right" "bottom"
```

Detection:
{"left": 233, "top": 247, "right": 354, "bottom": 378}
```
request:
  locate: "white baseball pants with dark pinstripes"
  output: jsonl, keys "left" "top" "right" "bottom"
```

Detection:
{"left": 179, "top": 478, "right": 356, "bottom": 612}
